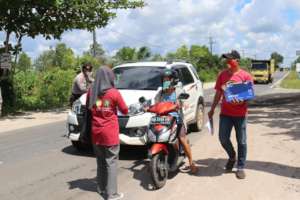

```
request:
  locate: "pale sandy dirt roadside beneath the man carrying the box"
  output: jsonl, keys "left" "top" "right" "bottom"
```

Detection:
{"left": 132, "top": 90, "right": 300, "bottom": 200}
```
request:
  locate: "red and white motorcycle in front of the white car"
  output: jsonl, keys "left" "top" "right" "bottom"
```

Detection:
{"left": 140, "top": 93, "right": 189, "bottom": 189}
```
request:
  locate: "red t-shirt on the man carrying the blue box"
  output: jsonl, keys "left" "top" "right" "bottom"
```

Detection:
{"left": 215, "top": 69, "right": 253, "bottom": 117}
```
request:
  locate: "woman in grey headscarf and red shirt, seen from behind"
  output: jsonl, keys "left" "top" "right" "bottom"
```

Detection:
{"left": 87, "top": 66, "right": 128, "bottom": 200}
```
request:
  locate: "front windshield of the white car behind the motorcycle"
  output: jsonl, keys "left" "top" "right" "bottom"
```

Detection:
{"left": 113, "top": 66, "right": 164, "bottom": 90}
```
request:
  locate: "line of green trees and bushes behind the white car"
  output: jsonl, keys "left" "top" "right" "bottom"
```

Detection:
{"left": 2, "top": 43, "right": 255, "bottom": 113}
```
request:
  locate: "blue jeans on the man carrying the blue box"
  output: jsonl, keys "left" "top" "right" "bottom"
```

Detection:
{"left": 219, "top": 115, "right": 247, "bottom": 169}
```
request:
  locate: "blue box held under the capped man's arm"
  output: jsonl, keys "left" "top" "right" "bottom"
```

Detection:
{"left": 224, "top": 82, "right": 255, "bottom": 102}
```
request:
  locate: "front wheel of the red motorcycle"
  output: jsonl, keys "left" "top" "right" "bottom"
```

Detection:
{"left": 150, "top": 152, "right": 168, "bottom": 189}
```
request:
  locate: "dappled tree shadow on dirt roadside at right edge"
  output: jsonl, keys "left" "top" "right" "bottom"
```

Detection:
{"left": 248, "top": 93, "right": 300, "bottom": 140}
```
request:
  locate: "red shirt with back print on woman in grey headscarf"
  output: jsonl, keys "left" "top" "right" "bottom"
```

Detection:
{"left": 88, "top": 88, "right": 128, "bottom": 146}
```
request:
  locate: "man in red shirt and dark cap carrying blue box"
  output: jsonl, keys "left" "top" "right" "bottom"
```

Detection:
{"left": 208, "top": 50, "right": 253, "bottom": 179}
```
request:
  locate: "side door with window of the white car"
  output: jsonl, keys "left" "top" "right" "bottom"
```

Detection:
{"left": 175, "top": 66, "right": 198, "bottom": 123}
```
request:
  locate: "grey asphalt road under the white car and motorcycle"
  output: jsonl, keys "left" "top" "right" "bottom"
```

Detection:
{"left": 0, "top": 72, "right": 284, "bottom": 200}
